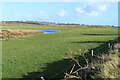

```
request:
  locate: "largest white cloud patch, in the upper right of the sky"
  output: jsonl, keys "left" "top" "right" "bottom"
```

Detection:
{"left": 75, "top": 3, "right": 108, "bottom": 17}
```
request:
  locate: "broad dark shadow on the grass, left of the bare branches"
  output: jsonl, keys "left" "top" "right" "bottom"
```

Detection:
{"left": 21, "top": 59, "right": 73, "bottom": 80}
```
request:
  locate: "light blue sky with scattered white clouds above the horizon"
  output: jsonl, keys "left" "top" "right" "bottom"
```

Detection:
{"left": 0, "top": 1, "right": 118, "bottom": 26}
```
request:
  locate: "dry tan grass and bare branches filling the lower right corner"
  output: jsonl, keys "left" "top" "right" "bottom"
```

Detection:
{"left": 63, "top": 43, "right": 120, "bottom": 80}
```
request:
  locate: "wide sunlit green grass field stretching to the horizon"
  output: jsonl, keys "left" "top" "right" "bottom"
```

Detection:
{"left": 2, "top": 23, "right": 118, "bottom": 78}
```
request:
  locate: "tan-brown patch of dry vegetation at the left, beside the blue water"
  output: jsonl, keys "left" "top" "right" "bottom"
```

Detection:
{"left": 0, "top": 29, "right": 43, "bottom": 40}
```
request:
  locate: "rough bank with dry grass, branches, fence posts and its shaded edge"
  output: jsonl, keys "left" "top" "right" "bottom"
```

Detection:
{"left": 64, "top": 39, "right": 120, "bottom": 80}
